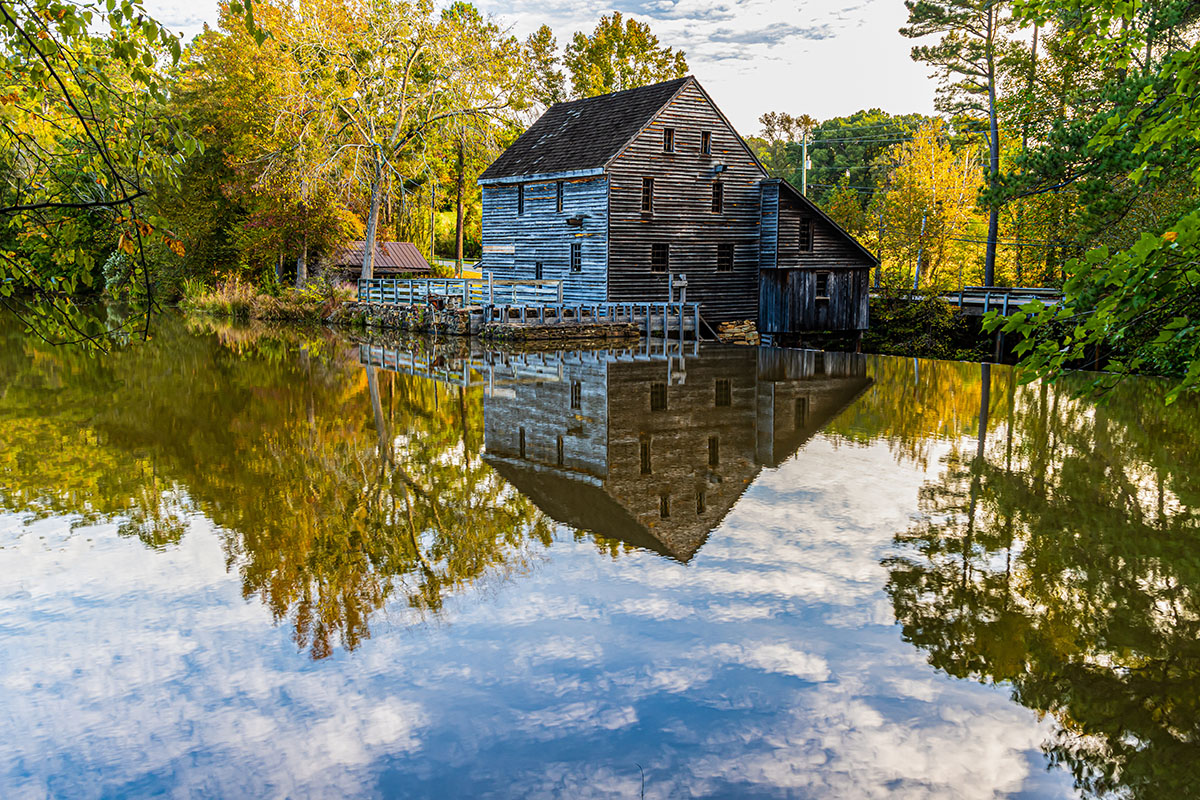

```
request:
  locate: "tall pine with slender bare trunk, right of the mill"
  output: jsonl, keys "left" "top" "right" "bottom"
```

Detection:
{"left": 900, "top": 0, "right": 1012, "bottom": 285}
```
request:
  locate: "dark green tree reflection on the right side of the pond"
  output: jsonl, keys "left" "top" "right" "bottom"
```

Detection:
{"left": 886, "top": 371, "right": 1200, "bottom": 798}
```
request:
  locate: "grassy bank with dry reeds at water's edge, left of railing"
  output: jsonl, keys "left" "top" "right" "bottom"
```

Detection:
{"left": 180, "top": 276, "right": 354, "bottom": 323}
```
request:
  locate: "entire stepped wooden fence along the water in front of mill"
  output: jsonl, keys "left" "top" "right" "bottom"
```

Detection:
{"left": 358, "top": 276, "right": 701, "bottom": 339}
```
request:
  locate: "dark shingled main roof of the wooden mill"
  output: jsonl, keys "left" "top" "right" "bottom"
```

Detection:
{"left": 479, "top": 76, "right": 691, "bottom": 181}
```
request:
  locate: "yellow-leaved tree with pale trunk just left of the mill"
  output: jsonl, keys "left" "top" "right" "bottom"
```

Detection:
{"left": 282, "top": 0, "right": 520, "bottom": 278}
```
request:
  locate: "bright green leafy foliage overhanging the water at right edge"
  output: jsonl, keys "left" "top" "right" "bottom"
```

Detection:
{"left": 986, "top": 0, "right": 1200, "bottom": 402}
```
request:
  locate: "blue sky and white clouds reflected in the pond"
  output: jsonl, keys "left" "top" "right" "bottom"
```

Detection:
{"left": 0, "top": 437, "right": 1072, "bottom": 799}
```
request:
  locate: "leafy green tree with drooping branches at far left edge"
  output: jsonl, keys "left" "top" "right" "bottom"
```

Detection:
{"left": 0, "top": 0, "right": 194, "bottom": 347}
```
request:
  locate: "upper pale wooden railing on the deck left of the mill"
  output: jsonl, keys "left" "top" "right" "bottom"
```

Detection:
{"left": 358, "top": 275, "right": 563, "bottom": 306}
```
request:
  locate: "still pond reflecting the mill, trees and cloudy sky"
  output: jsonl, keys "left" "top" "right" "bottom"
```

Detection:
{"left": 0, "top": 317, "right": 1200, "bottom": 799}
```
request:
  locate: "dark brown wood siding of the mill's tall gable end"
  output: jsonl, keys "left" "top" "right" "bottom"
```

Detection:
{"left": 608, "top": 83, "right": 766, "bottom": 323}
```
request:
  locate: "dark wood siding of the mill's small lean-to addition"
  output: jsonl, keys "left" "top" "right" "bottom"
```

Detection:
{"left": 758, "top": 182, "right": 874, "bottom": 333}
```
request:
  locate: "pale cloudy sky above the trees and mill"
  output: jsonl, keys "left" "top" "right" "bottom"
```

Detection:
{"left": 145, "top": 0, "right": 936, "bottom": 136}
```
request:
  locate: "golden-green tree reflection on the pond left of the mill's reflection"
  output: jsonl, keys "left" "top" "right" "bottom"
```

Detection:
{"left": 0, "top": 320, "right": 551, "bottom": 657}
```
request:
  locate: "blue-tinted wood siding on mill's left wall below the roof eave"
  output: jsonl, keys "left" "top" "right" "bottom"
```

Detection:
{"left": 482, "top": 176, "right": 608, "bottom": 302}
